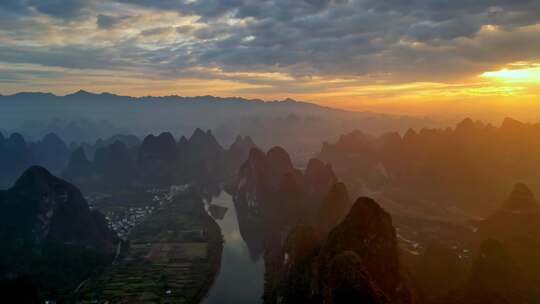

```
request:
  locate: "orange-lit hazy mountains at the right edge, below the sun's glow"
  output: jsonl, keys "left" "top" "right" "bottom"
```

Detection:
{"left": 319, "top": 118, "right": 540, "bottom": 219}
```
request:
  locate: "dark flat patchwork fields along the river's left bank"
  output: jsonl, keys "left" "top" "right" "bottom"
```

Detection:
{"left": 78, "top": 195, "right": 222, "bottom": 303}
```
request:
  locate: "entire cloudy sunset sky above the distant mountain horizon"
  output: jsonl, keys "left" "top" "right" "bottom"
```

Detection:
{"left": 0, "top": 0, "right": 540, "bottom": 120}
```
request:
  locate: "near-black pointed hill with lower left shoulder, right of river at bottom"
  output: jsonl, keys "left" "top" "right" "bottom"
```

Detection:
{"left": 278, "top": 198, "right": 418, "bottom": 304}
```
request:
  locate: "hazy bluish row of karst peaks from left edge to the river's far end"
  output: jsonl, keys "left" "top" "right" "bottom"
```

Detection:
{"left": 0, "top": 129, "right": 255, "bottom": 192}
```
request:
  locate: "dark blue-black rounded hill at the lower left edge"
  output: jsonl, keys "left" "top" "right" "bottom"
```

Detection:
{"left": 0, "top": 167, "right": 117, "bottom": 299}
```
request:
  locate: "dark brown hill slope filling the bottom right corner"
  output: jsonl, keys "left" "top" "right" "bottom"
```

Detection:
{"left": 430, "top": 183, "right": 540, "bottom": 304}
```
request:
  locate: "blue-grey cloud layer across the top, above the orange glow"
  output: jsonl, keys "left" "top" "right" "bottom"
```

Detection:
{"left": 0, "top": 0, "right": 540, "bottom": 98}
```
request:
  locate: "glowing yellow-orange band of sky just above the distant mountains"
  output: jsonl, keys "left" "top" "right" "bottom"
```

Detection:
{"left": 0, "top": 62, "right": 540, "bottom": 120}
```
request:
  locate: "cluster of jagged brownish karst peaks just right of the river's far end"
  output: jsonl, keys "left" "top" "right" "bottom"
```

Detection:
{"left": 228, "top": 147, "right": 336, "bottom": 229}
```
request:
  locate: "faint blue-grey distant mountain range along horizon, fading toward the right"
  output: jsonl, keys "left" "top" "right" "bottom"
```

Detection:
{"left": 0, "top": 90, "right": 433, "bottom": 155}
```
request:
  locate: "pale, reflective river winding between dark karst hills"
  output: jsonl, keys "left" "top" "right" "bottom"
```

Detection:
{"left": 202, "top": 191, "right": 264, "bottom": 304}
